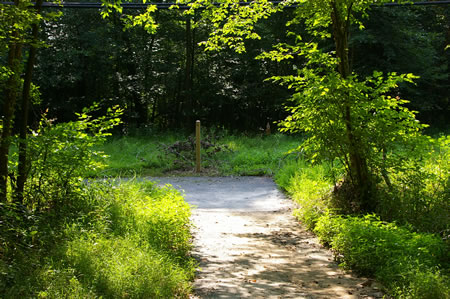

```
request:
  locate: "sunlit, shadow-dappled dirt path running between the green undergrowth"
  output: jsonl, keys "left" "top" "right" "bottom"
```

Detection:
{"left": 151, "top": 177, "right": 383, "bottom": 298}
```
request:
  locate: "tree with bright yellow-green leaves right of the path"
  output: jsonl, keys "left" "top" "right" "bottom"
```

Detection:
{"left": 173, "top": 0, "right": 428, "bottom": 211}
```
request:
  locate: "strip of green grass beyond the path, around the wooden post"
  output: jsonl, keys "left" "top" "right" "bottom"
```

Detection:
{"left": 90, "top": 133, "right": 301, "bottom": 177}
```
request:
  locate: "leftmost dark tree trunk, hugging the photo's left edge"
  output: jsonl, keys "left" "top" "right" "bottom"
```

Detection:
{"left": 0, "top": 0, "right": 22, "bottom": 201}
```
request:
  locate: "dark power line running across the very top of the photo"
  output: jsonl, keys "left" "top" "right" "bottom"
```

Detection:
{"left": 0, "top": 0, "right": 450, "bottom": 10}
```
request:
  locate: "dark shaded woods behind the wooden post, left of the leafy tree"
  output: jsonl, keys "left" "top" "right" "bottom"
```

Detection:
{"left": 35, "top": 9, "right": 292, "bottom": 132}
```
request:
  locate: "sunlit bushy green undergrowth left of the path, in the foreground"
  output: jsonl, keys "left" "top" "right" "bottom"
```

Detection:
{"left": 0, "top": 182, "right": 194, "bottom": 298}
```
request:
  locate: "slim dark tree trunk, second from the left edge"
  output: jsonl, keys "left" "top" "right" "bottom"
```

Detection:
{"left": 16, "top": 0, "right": 43, "bottom": 203}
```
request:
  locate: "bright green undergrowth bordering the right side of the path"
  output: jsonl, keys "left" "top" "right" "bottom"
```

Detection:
{"left": 275, "top": 137, "right": 450, "bottom": 299}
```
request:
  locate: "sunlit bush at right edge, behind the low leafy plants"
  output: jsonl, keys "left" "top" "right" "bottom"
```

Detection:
{"left": 377, "top": 136, "right": 450, "bottom": 238}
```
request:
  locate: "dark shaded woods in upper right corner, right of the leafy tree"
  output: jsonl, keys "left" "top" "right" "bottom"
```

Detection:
{"left": 349, "top": 5, "right": 450, "bottom": 129}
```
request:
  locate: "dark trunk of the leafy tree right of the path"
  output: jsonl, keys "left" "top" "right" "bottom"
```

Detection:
{"left": 331, "top": 1, "right": 373, "bottom": 210}
